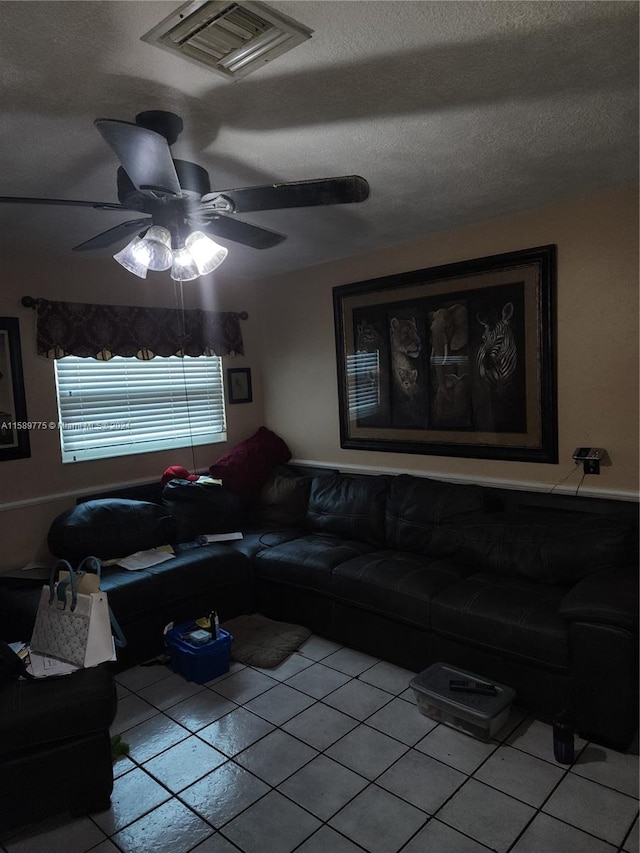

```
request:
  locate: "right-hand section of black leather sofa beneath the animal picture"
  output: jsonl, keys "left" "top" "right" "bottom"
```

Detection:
{"left": 245, "top": 473, "right": 638, "bottom": 748}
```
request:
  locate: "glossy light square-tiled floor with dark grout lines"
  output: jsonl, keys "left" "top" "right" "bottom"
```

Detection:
{"left": 0, "top": 636, "right": 639, "bottom": 853}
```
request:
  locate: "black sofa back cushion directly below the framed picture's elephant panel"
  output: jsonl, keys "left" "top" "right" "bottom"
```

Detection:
{"left": 385, "top": 474, "right": 484, "bottom": 555}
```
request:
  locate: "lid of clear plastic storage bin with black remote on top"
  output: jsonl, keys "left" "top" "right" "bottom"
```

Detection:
{"left": 409, "top": 662, "right": 516, "bottom": 719}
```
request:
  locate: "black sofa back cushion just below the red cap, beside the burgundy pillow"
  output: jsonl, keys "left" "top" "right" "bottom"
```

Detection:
{"left": 162, "top": 480, "right": 245, "bottom": 542}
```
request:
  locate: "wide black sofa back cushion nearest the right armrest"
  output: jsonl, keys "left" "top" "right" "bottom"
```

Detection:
{"left": 438, "top": 512, "right": 634, "bottom": 585}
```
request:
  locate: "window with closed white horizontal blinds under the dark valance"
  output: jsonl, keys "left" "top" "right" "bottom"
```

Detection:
{"left": 55, "top": 356, "right": 227, "bottom": 462}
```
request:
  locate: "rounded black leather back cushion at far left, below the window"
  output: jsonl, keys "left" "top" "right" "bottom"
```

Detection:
{"left": 47, "top": 498, "right": 175, "bottom": 562}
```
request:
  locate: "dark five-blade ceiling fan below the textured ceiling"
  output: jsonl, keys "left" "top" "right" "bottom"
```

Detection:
{"left": 0, "top": 110, "right": 369, "bottom": 274}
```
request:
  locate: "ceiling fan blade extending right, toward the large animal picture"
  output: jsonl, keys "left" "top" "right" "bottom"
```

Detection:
{"left": 202, "top": 175, "right": 369, "bottom": 213}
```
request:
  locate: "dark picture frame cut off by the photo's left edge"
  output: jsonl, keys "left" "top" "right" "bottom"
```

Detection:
{"left": 0, "top": 317, "right": 31, "bottom": 462}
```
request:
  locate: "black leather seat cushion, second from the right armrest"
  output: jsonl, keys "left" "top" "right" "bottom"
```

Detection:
{"left": 331, "top": 551, "right": 469, "bottom": 628}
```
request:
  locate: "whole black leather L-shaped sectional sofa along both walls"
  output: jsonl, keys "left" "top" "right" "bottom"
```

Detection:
{"left": 2, "top": 466, "right": 638, "bottom": 749}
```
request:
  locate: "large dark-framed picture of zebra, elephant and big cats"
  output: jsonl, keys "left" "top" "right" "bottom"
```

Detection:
{"left": 333, "top": 245, "right": 558, "bottom": 463}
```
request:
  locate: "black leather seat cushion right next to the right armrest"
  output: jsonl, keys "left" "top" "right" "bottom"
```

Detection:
{"left": 431, "top": 573, "right": 570, "bottom": 670}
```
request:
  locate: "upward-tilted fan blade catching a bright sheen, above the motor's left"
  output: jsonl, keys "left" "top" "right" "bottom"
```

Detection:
{"left": 94, "top": 118, "right": 180, "bottom": 195}
